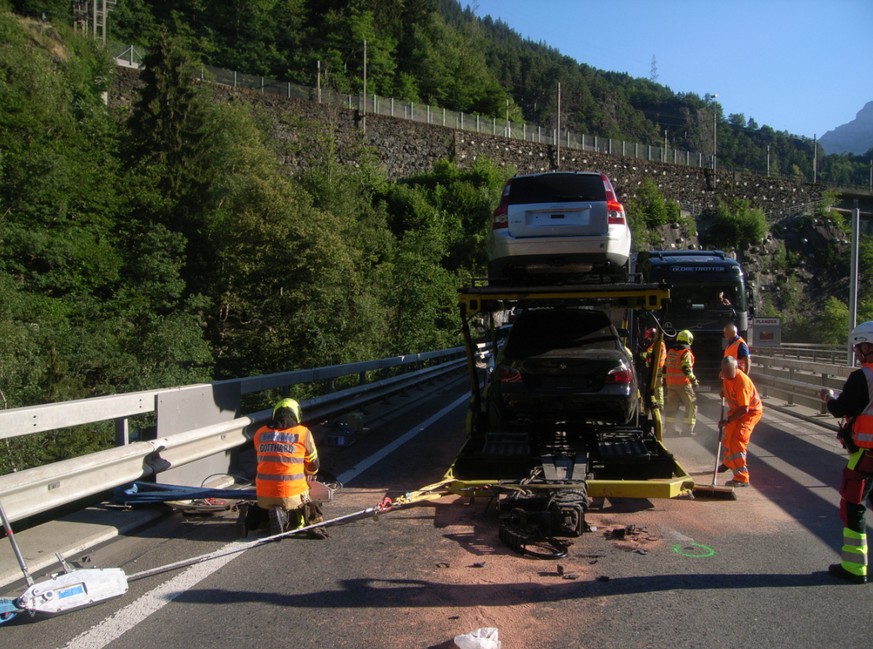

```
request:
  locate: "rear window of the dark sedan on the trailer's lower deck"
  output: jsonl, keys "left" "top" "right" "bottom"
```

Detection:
{"left": 504, "top": 310, "right": 618, "bottom": 360}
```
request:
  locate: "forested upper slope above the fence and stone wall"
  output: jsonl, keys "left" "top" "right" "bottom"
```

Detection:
{"left": 14, "top": 0, "right": 871, "bottom": 186}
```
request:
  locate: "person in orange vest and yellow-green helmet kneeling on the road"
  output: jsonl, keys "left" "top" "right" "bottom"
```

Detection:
{"left": 253, "top": 399, "right": 319, "bottom": 534}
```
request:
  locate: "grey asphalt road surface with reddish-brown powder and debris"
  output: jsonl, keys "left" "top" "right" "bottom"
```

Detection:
{"left": 0, "top": 375, "right": 873, "bottom": 649}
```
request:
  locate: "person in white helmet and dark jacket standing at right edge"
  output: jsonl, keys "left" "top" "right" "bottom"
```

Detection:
{"left": 821, "top": 322, "right": 873, "bottom": 584}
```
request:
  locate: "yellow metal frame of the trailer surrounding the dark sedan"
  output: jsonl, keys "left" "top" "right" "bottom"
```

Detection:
{"left": 443, "top": 284, "right": 694, "bottom": 498}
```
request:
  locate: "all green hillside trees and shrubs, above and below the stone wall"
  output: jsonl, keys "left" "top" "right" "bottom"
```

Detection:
{"left": 0, "top": 0, "right": 873, "bottom": 473}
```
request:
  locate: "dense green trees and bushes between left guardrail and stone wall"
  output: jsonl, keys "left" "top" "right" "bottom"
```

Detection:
{"left": 0, "top": 10, "right": 505, "bottom": 473}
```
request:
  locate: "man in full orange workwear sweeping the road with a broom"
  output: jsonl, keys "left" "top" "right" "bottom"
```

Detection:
{"left": 718, "top": 356, "right": 764, "bottom": 487}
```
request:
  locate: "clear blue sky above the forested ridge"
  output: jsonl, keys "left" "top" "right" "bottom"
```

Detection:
{"left": 460, "top": 0, "right": 873, "bottom": 138}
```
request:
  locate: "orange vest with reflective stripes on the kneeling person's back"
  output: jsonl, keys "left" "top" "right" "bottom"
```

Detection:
{"left": 254, "top": 426, "right": 310, "bottom": 498}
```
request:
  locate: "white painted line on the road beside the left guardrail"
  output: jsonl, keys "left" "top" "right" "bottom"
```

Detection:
{"left": 64, "top": 394, "right": 470, "bottom": 649}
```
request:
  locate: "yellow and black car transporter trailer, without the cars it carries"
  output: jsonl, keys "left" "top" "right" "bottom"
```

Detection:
{"left": 443, "top": 283, "right": 694, "bottom": 558}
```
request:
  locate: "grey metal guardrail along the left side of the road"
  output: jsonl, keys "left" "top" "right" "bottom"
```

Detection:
{"left": 0, "top": 347, "right": 474, "bottom": 520}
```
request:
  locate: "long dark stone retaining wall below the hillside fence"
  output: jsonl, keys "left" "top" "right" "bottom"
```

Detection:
{"left": 112, "top": 69, "right": 824, "bottom": 220}
